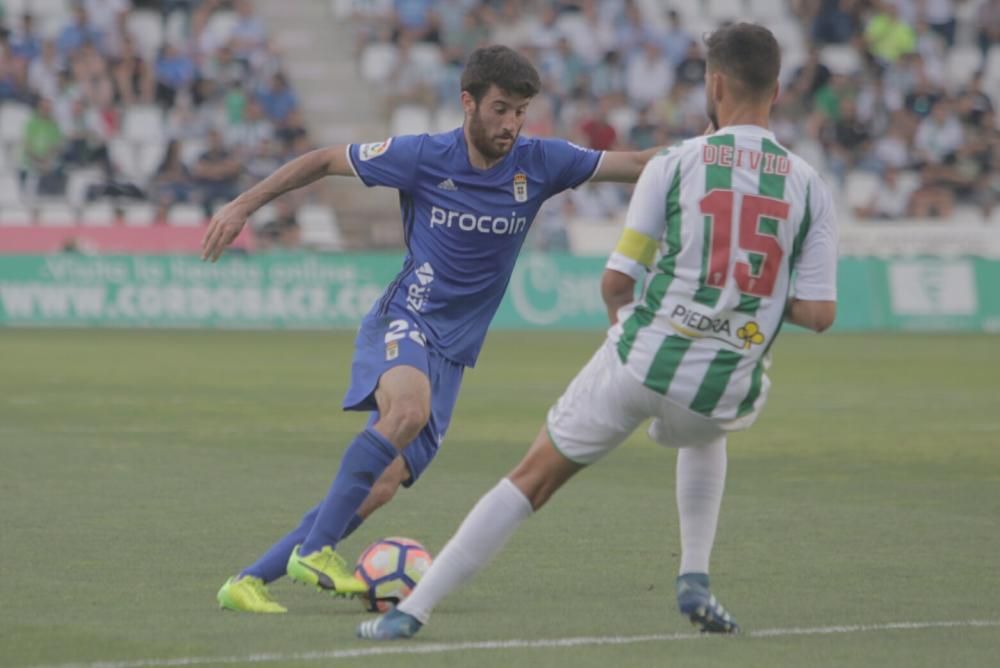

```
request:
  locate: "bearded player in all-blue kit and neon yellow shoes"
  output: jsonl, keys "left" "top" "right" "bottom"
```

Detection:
{"left": 202, "top": 46, "right": 657, "bottom": 612}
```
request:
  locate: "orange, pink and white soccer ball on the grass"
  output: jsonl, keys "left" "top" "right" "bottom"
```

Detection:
{"left": 354, "top": 538, "right": 431, "bottom": 612}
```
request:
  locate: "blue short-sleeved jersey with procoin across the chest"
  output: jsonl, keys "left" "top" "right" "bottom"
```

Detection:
{"left": 347, "top": 128, "right": 603, "bottom": 366}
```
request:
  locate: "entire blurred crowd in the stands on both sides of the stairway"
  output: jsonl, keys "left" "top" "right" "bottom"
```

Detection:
{"left": 0, "top": 0, "right": 1000, "bottom": 249}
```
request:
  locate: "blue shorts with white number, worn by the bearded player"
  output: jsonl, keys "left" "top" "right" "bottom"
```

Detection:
{"left": 344, "top": 310, "right": 465, "bottom": 487}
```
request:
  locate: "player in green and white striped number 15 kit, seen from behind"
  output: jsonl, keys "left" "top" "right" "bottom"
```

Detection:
{"left": 357, "top": 23, "right": 837, "bottom": 640}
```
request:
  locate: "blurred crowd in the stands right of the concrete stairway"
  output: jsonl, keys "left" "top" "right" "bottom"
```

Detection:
{"left": 353, "top": 0, "right": 1000, "bottom": 247}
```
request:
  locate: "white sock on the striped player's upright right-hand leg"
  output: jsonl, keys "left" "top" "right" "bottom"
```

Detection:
{"left": 677, "top": 438, "right": 726, "bottom": 574}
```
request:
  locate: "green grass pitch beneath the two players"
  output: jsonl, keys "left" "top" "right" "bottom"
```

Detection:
{"left": 0, "top": 330, "right": 1000, "bottom": 668}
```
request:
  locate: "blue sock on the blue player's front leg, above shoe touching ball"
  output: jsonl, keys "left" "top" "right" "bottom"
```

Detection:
{"left": 299, "top": 427, "right": 399, "bottom": 555}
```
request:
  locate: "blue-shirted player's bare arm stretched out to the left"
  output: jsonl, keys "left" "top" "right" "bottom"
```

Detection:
{"left": 201, "top": 144, "right": 354, "bottom": 262}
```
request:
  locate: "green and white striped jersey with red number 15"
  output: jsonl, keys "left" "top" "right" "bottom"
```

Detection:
{"left": 607, "top": 126, "right": 837, "bottom": 428}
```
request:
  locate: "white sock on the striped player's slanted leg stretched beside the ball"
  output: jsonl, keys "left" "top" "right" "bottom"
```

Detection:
{"left": 398, "top": 478, "right": 532, "bottom": 624}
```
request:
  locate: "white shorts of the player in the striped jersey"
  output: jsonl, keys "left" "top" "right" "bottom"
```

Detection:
{"left": 547, "top": 341, "right": 731, "bottom": 464}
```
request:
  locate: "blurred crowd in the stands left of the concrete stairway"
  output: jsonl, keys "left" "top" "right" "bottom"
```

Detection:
{"left": 0, "top": 0, "right": 311, "bottom": 246}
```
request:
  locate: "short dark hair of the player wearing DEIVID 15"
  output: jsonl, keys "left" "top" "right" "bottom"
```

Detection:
{"left": 705, "top": 23, "right": 781, "bottom": 99}
